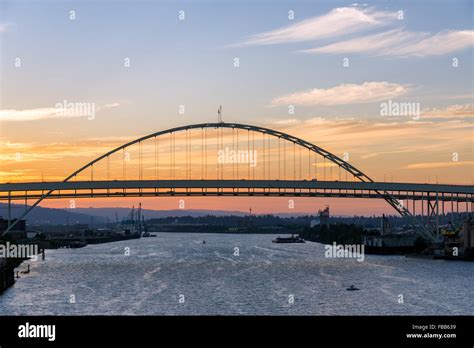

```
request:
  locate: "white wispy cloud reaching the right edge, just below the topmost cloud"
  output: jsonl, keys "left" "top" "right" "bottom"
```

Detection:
{"left": 299, "top": 29, "right": 474, "bottom": 57}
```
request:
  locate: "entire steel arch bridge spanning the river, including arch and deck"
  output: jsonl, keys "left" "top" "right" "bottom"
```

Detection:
{"left": 0, "top": 122, "right": 474, "bottom": 241}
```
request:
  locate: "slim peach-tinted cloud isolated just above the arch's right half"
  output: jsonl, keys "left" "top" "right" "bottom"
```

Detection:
{"left": 270, "top": 81, "right": 410, "bottom": 106}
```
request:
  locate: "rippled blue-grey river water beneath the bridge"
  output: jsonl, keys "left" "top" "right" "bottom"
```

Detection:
{"left": 0, "top": 233, "right": 474, "bottom": 315}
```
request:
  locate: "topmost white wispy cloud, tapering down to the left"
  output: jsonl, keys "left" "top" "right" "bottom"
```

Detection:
{"left": 231, "top": 7, "right": 397, "bottom": 46}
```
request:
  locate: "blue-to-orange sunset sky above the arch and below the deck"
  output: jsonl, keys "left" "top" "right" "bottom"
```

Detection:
{"left": 0, "top": 0, "right": 474, "bottom": 214}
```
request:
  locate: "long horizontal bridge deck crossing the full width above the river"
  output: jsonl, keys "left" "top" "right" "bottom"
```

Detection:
{"left": 0, "top": 180, "right": 474, "bottom": 202}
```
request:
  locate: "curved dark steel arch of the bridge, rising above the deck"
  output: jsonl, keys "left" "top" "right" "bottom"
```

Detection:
{"left": 3, "top": 122, "right": 436, "bottom": 240}
